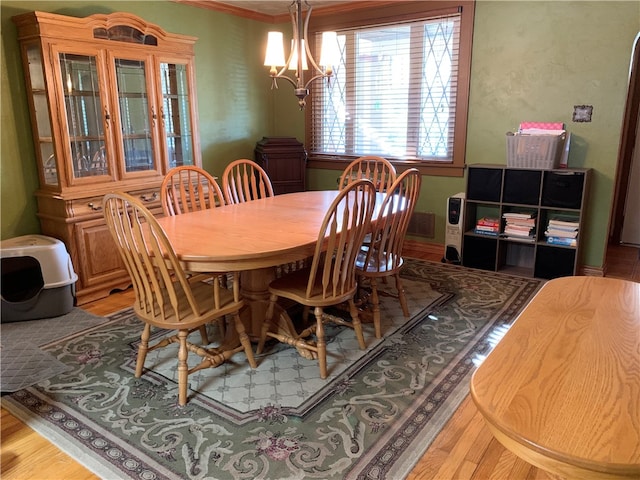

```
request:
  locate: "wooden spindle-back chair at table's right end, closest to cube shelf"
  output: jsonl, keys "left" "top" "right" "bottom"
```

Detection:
{"left": 356, "top": 168, "right": 422, "bottom": 338}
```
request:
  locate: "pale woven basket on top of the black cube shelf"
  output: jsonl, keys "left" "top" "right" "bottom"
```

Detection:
{"left": 507, "top": 133, "right": 565, "bottom": 170}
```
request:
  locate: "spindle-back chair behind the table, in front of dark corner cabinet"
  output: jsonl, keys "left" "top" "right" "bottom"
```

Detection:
{"left": 222, "top": 158, "right": 273, "bottom": 204}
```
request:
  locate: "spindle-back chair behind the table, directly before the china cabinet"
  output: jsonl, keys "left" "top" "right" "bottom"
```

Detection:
{"left": 160, "top": 165, "right": 225, "bottom": 215}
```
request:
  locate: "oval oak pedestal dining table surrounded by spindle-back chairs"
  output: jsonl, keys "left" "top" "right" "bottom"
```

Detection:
{"left": 158, "top": 190, "right": 384, "bottom": 357}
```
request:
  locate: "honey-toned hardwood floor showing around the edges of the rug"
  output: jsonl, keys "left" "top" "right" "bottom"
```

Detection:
{"left": 0, "top": 242, "right": 640, "bottom": 480}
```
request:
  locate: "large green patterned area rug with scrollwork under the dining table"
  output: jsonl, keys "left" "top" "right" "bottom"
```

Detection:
{"left": 2, "top": 260, "right": 542, "bottom": 480}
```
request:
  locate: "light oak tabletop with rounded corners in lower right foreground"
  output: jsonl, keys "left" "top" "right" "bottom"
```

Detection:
{"left": 471, "top": 277, "right": 640, "bottom": 479}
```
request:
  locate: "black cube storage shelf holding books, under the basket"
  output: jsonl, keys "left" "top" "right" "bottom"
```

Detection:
{"left": 462, "top": 164, "right": 590, "bottom": 279}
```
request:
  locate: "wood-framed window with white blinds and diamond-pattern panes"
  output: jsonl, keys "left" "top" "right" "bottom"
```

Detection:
{"left": 307, "top": 2, "right": 473, "bottom": 175}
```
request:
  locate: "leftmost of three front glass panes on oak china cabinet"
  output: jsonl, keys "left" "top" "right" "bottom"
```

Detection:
{"left": 58, "top": 53, "right": 111, "bottom": 178}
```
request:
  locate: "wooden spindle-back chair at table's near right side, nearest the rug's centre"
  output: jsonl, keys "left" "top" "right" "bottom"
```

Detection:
{"left": 257, "top": 179, "right": 376, "bottom": 378}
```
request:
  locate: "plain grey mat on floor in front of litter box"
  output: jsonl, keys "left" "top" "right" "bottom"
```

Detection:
{"left": 0, "top": 308, "right": 108, "bottom": 393}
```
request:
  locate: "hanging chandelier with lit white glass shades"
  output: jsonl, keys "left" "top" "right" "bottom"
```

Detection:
{"left": 264, "top": 0, "right": 339, "bottom": 110}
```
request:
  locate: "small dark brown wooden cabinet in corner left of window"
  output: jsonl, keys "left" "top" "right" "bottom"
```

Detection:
{"left": 254, "top": 137, "right": 307, "bottom": 195}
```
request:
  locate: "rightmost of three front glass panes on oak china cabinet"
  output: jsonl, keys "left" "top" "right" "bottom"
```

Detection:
{"left": 160, "top": 62, "right": 195, "bottom": 168}
